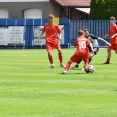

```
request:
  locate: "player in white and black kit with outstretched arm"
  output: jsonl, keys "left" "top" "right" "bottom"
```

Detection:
{"left": 72, "top": 29, "right": 111, "bottom": 69}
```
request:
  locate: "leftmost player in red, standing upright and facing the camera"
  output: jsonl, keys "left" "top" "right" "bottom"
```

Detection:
{"left": 38, "top": 15, "right": 64, "bottom": 68}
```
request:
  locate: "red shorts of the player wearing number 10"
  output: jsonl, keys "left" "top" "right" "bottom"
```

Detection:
{"left": 70, "top": 53, "right": 89, "bottom": 62}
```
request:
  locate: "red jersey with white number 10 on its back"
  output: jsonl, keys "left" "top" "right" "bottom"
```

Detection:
{"left": 74, "top": 37, "right": 90, "bottom": 55}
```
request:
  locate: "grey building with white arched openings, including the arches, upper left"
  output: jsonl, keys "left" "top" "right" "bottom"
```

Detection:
{"left": 0, "top": 0, "right": 50, "bottom": 18}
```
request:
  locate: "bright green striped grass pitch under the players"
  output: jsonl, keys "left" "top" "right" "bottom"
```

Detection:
{"left": 0, "top": 48, "right": 117, "bottom": 117}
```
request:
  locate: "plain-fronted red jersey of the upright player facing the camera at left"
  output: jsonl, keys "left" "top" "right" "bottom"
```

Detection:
{"left": 43, "top": 23, "right": 61, "bottom": 43}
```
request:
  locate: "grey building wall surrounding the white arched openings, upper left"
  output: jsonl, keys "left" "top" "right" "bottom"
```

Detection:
{"left": 0, "top": 2, "right": 50, "bottom": 18}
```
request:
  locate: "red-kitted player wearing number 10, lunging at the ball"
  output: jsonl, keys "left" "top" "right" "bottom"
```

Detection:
{"left": 62, "top": 30, "right": 94, "bottom": 74}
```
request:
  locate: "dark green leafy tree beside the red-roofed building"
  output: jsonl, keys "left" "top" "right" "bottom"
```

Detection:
{"left": 89, "top": 0, "right": 117, "bottom": 20}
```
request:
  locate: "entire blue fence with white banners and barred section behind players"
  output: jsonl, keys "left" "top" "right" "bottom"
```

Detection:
{"left": 0, "top": 18, "right": 110, "bottom": 48}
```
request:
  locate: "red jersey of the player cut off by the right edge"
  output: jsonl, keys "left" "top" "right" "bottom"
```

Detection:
{"left": 108, "top": 24, "right": 117, "bottom": 44}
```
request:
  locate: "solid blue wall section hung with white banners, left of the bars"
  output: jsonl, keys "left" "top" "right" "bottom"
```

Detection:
{"left": 0, "top": 18, "right": 69, "bottom": 48}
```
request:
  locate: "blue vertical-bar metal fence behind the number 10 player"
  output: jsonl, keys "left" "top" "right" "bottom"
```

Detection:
{"left": 70, "top": 20, "right": 110, "bottom": 46}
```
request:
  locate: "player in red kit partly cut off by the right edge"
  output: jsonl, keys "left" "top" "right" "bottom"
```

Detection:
{"left": 104, "top": 16, "right": 117, "bottom": 64}
